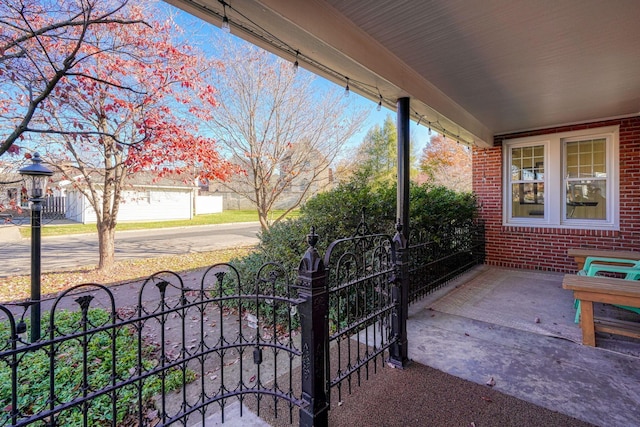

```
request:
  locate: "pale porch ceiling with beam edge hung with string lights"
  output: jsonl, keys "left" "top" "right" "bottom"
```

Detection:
{"left": 167, "top": 0, "right": 640, "bottom": 146}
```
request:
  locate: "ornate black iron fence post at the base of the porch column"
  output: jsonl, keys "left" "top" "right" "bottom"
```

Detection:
{"left": 389, "top": 222, "right": 409, "bottom": 368}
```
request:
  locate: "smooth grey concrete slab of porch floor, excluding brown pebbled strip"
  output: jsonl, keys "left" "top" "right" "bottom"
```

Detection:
{"left": 407, "top": 265, "right": 640, "bottom": 427}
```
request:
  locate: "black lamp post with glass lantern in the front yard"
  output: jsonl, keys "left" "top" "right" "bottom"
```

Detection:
{"left": 18, "top": 153, "right": 53, "bottom": 342}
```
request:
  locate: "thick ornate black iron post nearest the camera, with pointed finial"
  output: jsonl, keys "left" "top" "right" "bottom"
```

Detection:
{"left": 298, "top": 228, "right": 329, "bottom": 427}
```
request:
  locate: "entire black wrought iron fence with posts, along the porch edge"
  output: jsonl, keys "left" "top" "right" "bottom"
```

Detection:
{"left": 0, "top": 223, "right": 484, "bottom": 426}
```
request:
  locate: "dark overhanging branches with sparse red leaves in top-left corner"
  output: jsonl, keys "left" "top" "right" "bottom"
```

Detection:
{"left": 0, "top": 0, "right": 145, "bottom": 155}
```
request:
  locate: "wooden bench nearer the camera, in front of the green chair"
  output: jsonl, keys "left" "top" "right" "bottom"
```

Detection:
{"left": 562, "top": 274, "right": 640, "bottom": 347}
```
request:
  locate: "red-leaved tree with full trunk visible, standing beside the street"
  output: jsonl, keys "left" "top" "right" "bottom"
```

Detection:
{"left": 21, "top": 5, "right": 234, "bottom": 270}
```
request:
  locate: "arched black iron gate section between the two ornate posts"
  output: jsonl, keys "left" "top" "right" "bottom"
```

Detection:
{"left": 324, "top": 234, "right": 398, "bottom": 400}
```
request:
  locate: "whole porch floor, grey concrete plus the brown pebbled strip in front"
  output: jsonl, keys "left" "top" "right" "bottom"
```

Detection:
{"left": 330, "top": 265, "right": 640, "bottom": 426}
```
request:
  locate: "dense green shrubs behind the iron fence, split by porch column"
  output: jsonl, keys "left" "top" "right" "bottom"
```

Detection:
{"left": 232, "top": 178, "right": 477, "bottom": 330}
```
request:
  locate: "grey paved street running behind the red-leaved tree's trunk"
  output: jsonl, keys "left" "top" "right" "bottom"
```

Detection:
{"left": 0, "top": 223, "right": 260, "bottom": 277}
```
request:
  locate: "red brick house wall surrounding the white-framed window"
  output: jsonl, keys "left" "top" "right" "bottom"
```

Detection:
{"left": 473, "top": 116, "right": 640, "bottom": 272}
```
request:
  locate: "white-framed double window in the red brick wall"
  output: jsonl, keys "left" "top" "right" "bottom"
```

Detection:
{"left": 503, "top": 126, "right": 619, "bottom": 229}
